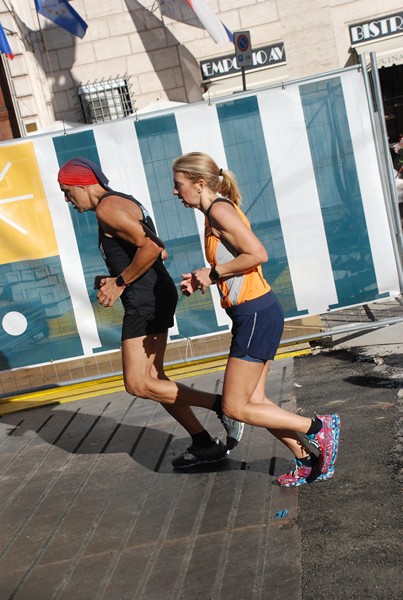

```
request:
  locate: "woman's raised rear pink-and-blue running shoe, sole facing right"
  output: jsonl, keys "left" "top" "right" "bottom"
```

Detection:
{"left": 298, "top": 414, "right": 340, "bottom": 474}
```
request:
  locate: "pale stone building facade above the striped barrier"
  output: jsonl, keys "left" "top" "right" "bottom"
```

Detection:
{"left": 0, "top": 0, "right": 403, "bottom": 141}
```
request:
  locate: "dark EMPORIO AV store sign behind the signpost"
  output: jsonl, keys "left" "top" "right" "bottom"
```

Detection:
{"left": 200, "top": 42, "right": 286, "bottom": 81}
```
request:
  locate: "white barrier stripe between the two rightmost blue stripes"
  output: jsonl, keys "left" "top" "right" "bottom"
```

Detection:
{"left": 257, "top": 85, "right": 337, "bottom": 314}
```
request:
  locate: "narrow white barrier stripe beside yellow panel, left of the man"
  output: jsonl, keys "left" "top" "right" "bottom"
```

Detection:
{"left": 33, "top": 136, "right": 101, "bottom": 356}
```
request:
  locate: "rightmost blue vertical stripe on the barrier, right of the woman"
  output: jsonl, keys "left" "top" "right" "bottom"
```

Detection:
{"left": 300, "top": 77, "right": 378, "bottom": 308}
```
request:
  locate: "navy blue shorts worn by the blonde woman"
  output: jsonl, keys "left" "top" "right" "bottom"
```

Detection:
{"left": 226, "top": 290, "right": 284, "bottom": 362}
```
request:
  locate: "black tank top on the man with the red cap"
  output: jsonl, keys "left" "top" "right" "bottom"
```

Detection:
{"left": 98, "top": 192, "right": 176, "bottom": 315}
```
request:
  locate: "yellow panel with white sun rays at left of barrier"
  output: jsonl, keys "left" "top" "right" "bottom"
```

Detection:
{"left": 0, "top": 142, "right": 59, "bottom": 264}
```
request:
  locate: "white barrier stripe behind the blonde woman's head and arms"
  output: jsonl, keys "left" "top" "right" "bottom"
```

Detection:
{"left": 176, "top": 103, "right": 231, "bottom": 327}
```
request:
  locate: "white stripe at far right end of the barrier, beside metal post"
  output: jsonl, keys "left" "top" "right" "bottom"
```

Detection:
{"left": 342, "top": 71, "right": 400, "bottom": 294}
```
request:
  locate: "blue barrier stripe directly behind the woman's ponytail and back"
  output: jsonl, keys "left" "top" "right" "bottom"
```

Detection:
{"left": 217, "top": 96, "right": 306, "bottom": 317}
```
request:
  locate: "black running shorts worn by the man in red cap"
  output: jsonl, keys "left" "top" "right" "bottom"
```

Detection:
{"left": 122, "top": 282, "right": 178, "bottom": 341}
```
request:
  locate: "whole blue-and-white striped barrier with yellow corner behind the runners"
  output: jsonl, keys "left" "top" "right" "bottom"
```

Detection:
{"left": 0, "top": 68, "right": 400, "bottom": 370}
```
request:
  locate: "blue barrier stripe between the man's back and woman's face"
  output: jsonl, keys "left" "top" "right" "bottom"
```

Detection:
{"left": 135, "top": 115, "right": 228, "bottom": 338}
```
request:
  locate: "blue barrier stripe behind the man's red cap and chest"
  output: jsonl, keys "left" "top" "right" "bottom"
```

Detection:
{"left": 53, "top": 130, "right": 123, "bottom": 352}
